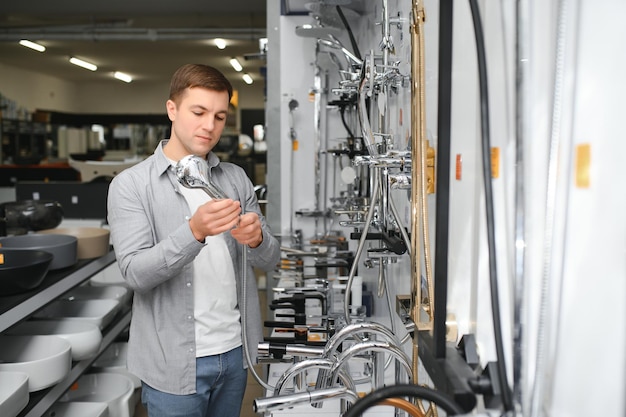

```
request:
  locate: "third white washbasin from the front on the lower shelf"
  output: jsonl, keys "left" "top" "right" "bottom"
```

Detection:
{"left": 6, "top": 319, "right": 102, "bottom": 361}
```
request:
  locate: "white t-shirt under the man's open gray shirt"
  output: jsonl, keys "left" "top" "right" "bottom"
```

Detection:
{"left": 171, "top": 161, "right": 241, "bottom": 357}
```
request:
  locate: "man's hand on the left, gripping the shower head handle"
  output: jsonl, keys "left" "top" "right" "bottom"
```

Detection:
{"left": 189, "top": 199, "right": 241, "bottom": 242}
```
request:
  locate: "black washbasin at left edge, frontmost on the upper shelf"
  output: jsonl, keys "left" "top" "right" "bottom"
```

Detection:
{"left": 0, "top": 249, "right": 54, "bottom": 295}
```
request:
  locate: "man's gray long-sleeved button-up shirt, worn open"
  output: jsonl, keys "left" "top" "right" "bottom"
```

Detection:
{"left": 107, "top": 141, "right": 280, "bottom": 395}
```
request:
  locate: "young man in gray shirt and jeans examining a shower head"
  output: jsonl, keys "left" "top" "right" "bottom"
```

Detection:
{"left": 108, "top": 64, "right": 280, "bottom": 417}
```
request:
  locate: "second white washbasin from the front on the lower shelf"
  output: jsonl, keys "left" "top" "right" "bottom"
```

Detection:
{"left": 0, "top": 335, "right": 72, "bottom": 392}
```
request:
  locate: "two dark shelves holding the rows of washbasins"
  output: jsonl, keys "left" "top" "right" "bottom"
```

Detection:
{"left": 0, "top": 250, "right": 131, "bottom": 417}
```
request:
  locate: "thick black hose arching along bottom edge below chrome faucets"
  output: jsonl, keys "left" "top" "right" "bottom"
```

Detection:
{"left": 343, "top": 384, "right": 465, "bottom": 417}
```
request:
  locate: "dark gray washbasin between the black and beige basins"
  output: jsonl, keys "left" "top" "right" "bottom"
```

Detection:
{"left": 0, "top": 233, "right": 78, "bottom": 270}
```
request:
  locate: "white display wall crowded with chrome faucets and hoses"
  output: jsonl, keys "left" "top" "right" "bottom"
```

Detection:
{"left": 258, "top": 0, "right": 626, "bottom": 416}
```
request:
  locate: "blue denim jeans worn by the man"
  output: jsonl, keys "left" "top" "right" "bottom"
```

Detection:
{"left": 141, "top": 346, "right": 248, "bottom": 417}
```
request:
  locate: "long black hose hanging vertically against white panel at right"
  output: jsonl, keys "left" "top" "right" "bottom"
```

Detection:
{"left": 469, "top": 0, "right": 514, "bottom": 412}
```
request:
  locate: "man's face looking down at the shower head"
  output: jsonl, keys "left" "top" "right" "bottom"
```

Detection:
{"left": 166, "top": 87, "right": 228, "bottom": 160}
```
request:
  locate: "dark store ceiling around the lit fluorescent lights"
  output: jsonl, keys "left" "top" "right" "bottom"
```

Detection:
{"left": 0, "top": 0, "right": 266, "bottom": 84}
